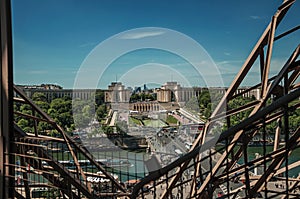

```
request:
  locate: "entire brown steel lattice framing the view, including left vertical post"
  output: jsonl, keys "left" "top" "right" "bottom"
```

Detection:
{"left": 0, "top": 0, "right": 300, "bottom": 199}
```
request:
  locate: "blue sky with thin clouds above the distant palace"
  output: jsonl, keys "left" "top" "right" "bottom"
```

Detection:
{"left": 12, "top": 0, "right": 300, "bottom": 88}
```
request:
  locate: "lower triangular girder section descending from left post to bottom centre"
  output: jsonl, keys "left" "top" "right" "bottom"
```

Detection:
{"left": 12, "top": 82, "right": 128, "bottom": 198}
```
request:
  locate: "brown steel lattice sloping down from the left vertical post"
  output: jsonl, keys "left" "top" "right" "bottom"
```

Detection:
{"left": 13, "top": 86, "right": 128, "bottom": 198}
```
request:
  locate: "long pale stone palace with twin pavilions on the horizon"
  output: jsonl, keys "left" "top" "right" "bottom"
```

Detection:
{"left": 18, "top": 82, "right": 260, "bottom": 105}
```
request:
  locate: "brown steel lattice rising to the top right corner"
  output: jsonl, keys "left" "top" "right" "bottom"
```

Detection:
{"left": 132, "top": 0, "right": 300, "bottom": 198}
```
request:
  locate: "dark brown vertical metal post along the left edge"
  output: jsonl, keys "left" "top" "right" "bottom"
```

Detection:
{"left": 0, "top": 0, "right": 14, "bottom": 199}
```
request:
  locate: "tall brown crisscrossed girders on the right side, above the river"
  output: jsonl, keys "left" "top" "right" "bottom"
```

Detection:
{"left": 132, "top": 0, "right": 300, "bottom": 199}
